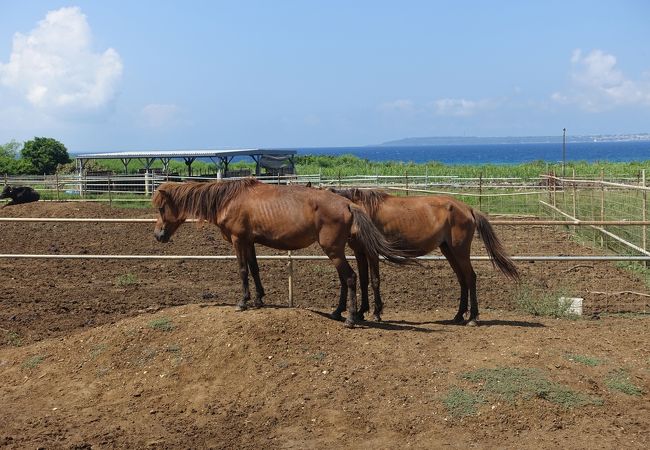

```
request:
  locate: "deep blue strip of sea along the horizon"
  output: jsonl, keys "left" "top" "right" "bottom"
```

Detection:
{"left": 298, "top": 141, "right": 650, "bottom": 164}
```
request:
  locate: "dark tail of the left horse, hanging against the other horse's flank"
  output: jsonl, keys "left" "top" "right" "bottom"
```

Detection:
{"left": 349, "top": 203, "right": 418, "bottom": 265}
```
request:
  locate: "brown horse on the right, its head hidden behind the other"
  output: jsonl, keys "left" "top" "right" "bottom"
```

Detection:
{"left": 330, "top": 189, "right": 519, "bottom": 325}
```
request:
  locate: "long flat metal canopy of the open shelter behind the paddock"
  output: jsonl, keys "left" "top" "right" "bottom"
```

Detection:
{"left": 76, "top": 148, "right": 297, "bottom": 176}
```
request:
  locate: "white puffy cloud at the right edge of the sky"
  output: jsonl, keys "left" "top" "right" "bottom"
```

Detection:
{"left": 551, "top": 49, "right": 650, "bottom": 112}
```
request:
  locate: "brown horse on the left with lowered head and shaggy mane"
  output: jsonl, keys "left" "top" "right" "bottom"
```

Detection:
{"left": 152, "top": 178, "right": 408, "bottom": 327}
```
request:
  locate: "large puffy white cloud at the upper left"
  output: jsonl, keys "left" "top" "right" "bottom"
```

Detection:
{"left": 0, "top": 7, "right": 122, "bottom": 114}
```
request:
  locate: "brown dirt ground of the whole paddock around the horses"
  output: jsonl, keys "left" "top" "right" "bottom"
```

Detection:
{"left": 0, "top": 203, "right": 650, "bottom": 448}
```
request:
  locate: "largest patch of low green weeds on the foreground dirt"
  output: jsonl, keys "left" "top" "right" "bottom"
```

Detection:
{"left": 461, "top": 367, "right": 602, "bottom": 408}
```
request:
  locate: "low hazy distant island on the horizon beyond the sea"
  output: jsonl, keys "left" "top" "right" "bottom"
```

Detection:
{"left": 378, "top": 133, "right": 650, "bottom": 147}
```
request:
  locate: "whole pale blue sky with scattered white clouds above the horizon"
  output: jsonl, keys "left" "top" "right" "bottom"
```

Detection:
{"left": 0, "top": 0, "right": 650, "bottom": 152}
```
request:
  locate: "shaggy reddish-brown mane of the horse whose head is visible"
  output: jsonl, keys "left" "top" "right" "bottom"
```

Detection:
{"left": 151, "top": 178, "right": 260, "bottom": 222}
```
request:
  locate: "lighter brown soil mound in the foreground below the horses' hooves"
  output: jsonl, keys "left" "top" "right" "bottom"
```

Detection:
{"left": 0, "top": 304, "right": 650, "bottom": 448}
